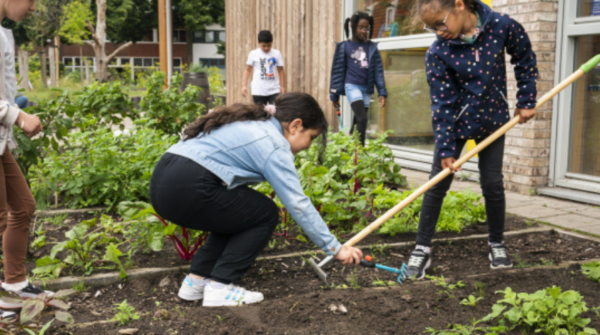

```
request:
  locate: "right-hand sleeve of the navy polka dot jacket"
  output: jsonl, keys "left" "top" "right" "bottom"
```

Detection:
{"left": 506, "top": 18, "right": 538, "bottom": 109}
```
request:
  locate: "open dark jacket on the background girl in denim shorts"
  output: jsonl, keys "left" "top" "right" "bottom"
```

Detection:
{"left": 329, "top": 41, "right": 387, "bottom": 102}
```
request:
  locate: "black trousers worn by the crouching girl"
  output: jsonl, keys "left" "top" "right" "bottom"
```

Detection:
{"left": 150, "top": 153, "right": 279, "bottom": 284}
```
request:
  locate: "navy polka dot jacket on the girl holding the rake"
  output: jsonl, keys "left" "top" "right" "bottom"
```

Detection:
{"left": 425, "top": 1, "right": 538, "bottom": 158}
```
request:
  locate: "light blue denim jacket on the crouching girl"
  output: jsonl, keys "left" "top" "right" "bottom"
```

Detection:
{"left": 167, "top": 117, "right": 341, "bottom": 255}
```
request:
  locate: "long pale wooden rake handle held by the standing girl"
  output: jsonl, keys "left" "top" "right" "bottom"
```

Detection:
{"left": 344, "top": 55, "right": 600, "bottom": 246}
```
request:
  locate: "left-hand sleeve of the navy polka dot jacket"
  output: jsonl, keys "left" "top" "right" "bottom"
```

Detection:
{"left": 425, "top": 49, "right": 458, "bottom": 158}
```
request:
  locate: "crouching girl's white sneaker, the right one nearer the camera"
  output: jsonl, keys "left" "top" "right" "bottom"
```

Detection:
{"left": 202, "top": 283, "right": 265, "bottom": 307}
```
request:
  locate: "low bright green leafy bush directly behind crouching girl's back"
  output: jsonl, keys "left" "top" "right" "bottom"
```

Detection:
{"left": 30, "top": 128, "right": 177, "bottom": 208}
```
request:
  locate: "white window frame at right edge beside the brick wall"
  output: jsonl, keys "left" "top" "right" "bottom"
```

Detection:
{"left": 549, "top": 0, "right": 600, "bottom": 193}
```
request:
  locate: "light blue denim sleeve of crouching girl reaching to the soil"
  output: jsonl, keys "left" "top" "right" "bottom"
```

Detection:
{"left": 263, "top": 148, "right": 342, "bottom": 256}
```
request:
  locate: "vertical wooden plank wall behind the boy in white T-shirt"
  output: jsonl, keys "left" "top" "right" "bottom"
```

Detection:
{"left": 225, "top": 0, "right": 342, "bottom": 129}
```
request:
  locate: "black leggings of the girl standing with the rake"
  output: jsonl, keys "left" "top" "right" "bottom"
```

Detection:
{"left": 417, "top": 136, "right": 506, "bottom": 247}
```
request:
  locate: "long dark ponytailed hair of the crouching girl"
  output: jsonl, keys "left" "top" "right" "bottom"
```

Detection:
{"left": 183, "top": 92, "right": 328, "bottom": 156}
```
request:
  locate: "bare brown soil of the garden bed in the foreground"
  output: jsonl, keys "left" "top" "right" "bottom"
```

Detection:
{"left": 41, "top": 234, "right": 600, "bottom": 334}
